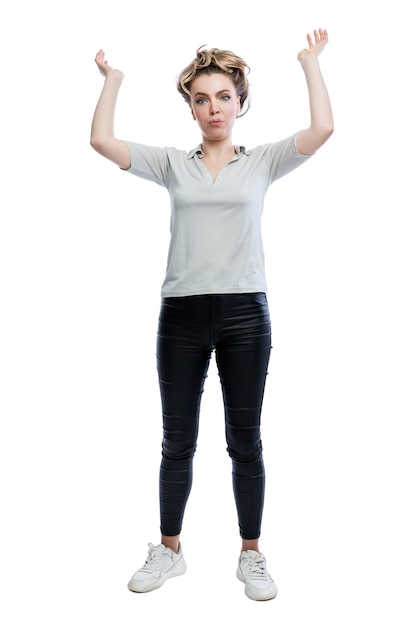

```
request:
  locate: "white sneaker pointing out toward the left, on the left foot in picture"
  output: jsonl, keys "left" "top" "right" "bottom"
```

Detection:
{"left": 128, "top": 543, "right": 187, "bottom": 593}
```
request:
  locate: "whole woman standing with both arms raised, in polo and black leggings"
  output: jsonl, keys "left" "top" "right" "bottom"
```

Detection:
{"left": 91, "top": 30, "right": 333, "bottom": 600}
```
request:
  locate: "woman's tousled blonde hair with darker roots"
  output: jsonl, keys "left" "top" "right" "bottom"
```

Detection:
{"left": 177, "top": 46, "right": 250, "bottom": 117}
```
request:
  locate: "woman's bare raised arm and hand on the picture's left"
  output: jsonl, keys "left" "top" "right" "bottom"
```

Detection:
{"left": 90, "top": 50, "right": 130, "bottom": 170}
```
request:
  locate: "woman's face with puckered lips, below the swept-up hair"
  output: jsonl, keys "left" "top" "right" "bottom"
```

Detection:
{"left": 190, "top": 73, "right": 240, "bottom": 141}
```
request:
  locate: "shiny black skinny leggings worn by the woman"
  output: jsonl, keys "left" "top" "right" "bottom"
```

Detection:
{"left": 157, "top": 293, "right": 271, "bottom": 539}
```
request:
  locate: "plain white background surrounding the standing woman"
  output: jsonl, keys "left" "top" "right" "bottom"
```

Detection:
{"left": 0, "top": 0, "right": 417, "bottom": 626}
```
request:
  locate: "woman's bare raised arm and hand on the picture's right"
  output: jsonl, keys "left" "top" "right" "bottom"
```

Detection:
{"left": 297, "top": 29, "right": 334, "bottom": 154}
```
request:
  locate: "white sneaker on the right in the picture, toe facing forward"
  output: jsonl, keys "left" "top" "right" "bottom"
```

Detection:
{"left": 236, "top": 550, "right": 278, "bottom": 600}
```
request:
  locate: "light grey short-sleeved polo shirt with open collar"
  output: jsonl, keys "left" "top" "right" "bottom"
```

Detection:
{"left": 126, "top": 135, "right": 309, "bottom": 297}
